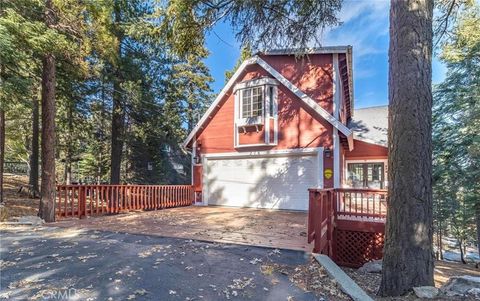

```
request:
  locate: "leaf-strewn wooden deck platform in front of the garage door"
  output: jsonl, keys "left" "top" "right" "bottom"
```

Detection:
{"left": 49, "top": 206, "right": 312, "bottom": 252}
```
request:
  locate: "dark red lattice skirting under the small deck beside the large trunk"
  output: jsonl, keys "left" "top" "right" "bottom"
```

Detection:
{"left": 333, "top": 228, "right": 384, "bottom": 268}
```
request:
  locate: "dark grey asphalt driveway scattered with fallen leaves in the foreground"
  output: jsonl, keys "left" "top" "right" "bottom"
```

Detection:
{"left": 0, "top": 226, "right": 338, "bottom": 300}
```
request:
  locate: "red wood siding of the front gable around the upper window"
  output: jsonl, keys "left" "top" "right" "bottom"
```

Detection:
{"left": 197, "top": 61, "right": 332, "bottom": 154}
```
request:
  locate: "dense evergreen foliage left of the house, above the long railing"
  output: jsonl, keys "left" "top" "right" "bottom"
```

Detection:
{"left": 0, "top": 0, "right": 212, "bottom": 184}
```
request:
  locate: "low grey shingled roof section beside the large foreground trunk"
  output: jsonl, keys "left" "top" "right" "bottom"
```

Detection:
{"left": 348, "top": 106, "right": 388, "bottom": 147}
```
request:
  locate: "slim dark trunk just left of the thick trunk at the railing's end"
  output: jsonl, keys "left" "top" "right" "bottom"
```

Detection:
{"left": 28, "top": 89, "right": 40, "bottom": 198}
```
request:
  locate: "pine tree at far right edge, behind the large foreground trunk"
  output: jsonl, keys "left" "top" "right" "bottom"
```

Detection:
{"left": 433, "top": 4, "right": 480, "bottom": 260}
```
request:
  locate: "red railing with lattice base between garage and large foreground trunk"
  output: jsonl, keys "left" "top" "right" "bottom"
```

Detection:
{"left": 308, "top": 188, "right": 387, "bottom": 267}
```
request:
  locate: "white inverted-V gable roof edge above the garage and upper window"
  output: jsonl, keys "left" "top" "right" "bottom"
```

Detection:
{"left": 183, "top": 55, "right": 353, "bottom": 148}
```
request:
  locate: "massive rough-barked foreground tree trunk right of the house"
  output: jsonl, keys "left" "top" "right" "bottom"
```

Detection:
{"left": 379, "top": 0, "right": 434, "bottom": 296}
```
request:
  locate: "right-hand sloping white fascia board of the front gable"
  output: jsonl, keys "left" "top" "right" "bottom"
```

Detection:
{"left": 257, "top": 58, "right": 353, "bottom": 137}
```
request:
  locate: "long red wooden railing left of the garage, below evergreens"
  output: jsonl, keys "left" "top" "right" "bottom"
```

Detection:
{"left": 56, "top": 185, "right": 195, "bottom": 218}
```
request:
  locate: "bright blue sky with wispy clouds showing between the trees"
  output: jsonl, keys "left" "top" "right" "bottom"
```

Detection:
{"left": 202, "top": 0, "right": 446, "bottom": 108}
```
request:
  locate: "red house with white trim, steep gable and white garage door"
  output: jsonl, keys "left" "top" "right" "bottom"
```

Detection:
{"left": 184, "top": 46, "right": 387, "bottom": 210}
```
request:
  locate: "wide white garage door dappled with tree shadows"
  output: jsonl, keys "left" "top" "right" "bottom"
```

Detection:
{"left": 205, "top": 155, "right": 319, "bottom": 210}
